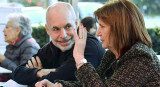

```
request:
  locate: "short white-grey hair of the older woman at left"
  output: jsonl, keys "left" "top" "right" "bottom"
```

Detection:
{"left": 7, "top": 13, "right": 32, "bottom": 37}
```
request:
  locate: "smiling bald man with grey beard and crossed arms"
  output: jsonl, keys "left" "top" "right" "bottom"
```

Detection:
{"left": 13, "top": 2, "right": 105, "bottom": 85}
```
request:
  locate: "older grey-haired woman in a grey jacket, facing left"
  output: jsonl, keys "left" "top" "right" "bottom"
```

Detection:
{"left": 0, "top": 13, "right": 40, "bottom": 71}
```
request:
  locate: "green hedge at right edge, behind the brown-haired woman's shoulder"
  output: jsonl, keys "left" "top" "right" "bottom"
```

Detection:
{"left": 147, "top": 27, "right": 160, "bottom": 55}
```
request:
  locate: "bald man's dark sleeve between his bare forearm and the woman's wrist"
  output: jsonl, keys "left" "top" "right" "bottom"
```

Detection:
{"left": 40, "top": 58, "right": 76, "bottom": 82}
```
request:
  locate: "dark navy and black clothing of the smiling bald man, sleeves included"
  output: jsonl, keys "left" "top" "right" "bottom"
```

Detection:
{"left": 12, "top": 33, "right": 105, "bottom": 85}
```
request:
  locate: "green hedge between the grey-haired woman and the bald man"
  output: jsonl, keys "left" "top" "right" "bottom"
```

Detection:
{"left": 32, "top": 25, "right": 50, "bottom": 47}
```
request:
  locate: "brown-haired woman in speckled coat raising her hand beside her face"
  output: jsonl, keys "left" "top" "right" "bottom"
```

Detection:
{"left": 36, "top": 0, "right": 160, "bottom": 87}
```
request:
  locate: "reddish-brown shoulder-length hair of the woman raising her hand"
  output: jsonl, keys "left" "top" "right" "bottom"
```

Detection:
{"left": 94, "top": 0, "right": 152, "bottom": 55}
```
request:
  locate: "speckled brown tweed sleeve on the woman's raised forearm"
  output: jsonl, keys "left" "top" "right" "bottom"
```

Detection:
{"left": 76, "top": 63, "right": 106, "bottom": 87}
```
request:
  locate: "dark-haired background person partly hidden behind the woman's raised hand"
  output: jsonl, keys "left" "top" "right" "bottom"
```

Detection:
{"left": 81, "top": 17, "right": 97, "bottom": 36}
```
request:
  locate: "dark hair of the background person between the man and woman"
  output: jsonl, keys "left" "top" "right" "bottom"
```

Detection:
{"left": 81, "top": 17, "right": 96, "bottom": 32}
